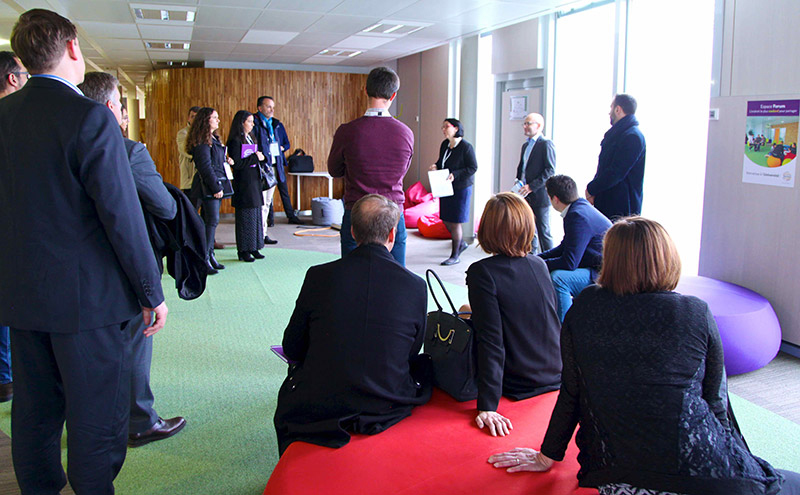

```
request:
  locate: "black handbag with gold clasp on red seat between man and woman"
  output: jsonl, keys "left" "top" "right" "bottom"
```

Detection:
{"left": 424, "top": 270, "right": 478, "bottom": 402}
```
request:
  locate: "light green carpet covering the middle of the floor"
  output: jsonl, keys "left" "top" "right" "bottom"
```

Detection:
{"left": 0, "top": 248, "right": 800, "bottom": 495}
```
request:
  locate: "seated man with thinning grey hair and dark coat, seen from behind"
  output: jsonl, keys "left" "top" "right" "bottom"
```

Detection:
{"left": 275, "top": 194, "right": 431, "bottom": 454}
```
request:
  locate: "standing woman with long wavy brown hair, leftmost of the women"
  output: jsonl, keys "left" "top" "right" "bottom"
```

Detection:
{"left": 186, "top": 107, "right": 233, "bottom": 275}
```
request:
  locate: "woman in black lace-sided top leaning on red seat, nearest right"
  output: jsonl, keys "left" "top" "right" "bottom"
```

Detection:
{"left": 489, "top": 217, "right": 800, "bottom": 495}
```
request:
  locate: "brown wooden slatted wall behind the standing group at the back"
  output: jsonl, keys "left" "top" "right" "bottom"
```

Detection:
{"left": 145, "top": 68, "right": 367, "bottom": 213}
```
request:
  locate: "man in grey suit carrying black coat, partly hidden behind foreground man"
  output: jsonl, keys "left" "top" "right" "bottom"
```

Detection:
{"left": 78, "top": 72, "right": 186, "bottom": 447}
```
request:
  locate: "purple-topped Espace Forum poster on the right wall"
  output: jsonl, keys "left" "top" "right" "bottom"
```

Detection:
{"left": 742, "top": 100, "right": 800, "bottom": 187}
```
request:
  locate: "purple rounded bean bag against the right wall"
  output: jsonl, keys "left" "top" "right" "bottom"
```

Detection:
{"left": 675, "top": 277, "right": 781, "bottom": 375}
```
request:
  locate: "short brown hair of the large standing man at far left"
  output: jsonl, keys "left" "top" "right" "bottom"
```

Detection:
{"left": 11, "top": 9, "right": 78, "bottom": 74}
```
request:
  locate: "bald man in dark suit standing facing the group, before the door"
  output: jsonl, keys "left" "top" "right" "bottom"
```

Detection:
{"left": 517, "top": 113, "right": 556, "bottom": 252}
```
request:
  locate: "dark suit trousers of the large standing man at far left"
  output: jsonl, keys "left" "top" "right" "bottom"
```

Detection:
{"left": 11, "top": 322, "right": 131, "bottom": 495}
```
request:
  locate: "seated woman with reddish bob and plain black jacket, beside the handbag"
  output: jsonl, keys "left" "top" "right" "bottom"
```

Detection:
{"left": 467, "top": 193, "right": 561, "bottom": 436}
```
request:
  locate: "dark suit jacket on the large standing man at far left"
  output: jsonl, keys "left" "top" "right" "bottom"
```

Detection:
{"left": 0, "top": 77, "right": 164, "bottom": 333}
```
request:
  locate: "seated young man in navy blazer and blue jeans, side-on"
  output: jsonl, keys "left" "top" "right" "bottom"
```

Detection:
{"left": 539, "top": 175, "right": 611, "bottom": 321}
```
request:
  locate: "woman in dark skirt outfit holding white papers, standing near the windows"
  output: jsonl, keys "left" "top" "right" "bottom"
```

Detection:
{"left": 430, "top": 119, "right": 478, "bottom": 265}
